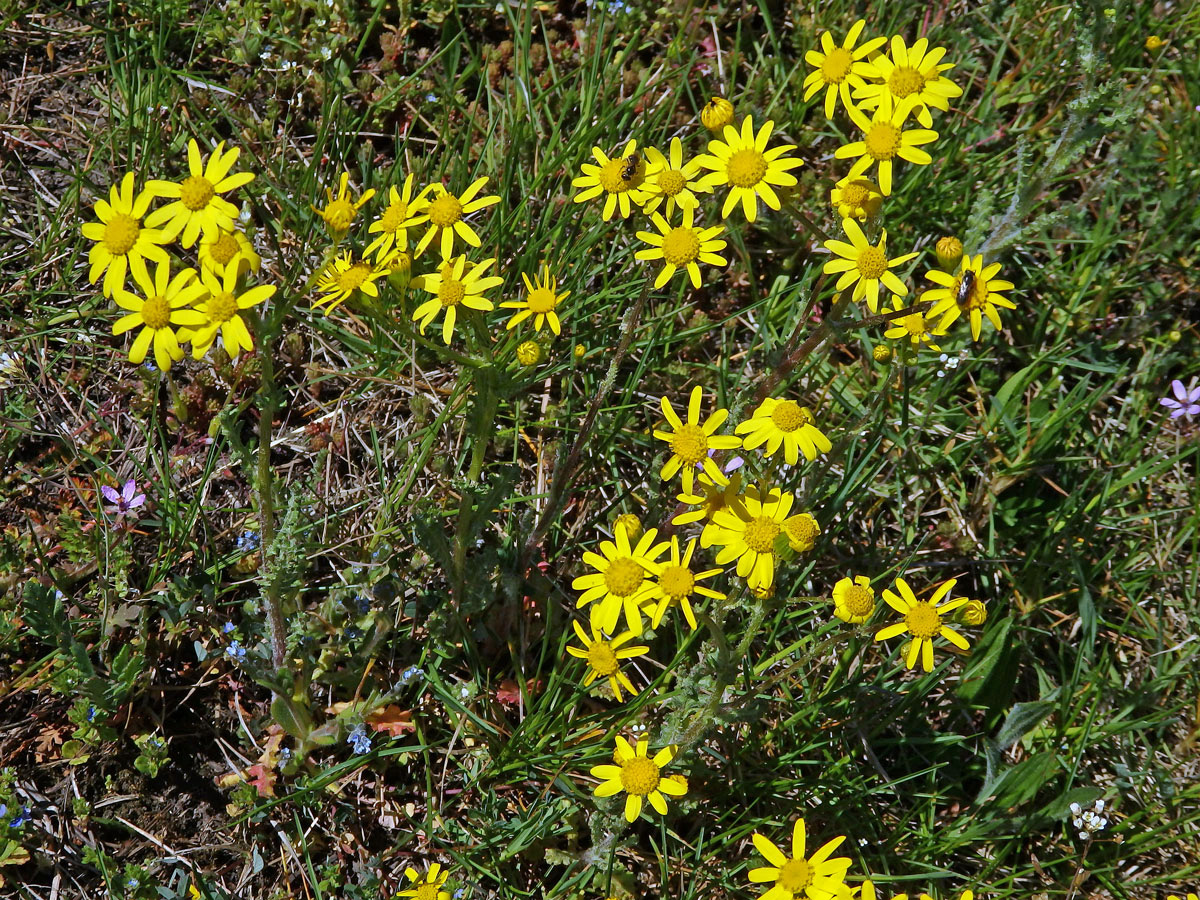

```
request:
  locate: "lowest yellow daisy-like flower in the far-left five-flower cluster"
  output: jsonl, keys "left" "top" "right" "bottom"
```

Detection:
{"left": 113, "top": 263, "right": 205, "bottom": 372}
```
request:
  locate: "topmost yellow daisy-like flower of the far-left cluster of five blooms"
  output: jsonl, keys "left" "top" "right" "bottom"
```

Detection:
{"left": 146, "top": 139, "right": 254, "bottom": 248}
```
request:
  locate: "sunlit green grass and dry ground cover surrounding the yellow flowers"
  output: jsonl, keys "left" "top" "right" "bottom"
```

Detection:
{"left": 0, "top": 0, "right": 1200, "bottom": 900}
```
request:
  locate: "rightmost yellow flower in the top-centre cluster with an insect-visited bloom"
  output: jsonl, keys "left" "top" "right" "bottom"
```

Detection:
{"left": 696, "top": 115, "right": 804, "bottom": 222}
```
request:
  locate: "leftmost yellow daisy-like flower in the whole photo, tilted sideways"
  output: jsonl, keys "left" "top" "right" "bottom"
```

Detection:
{"left": 82, "top": 172, "right": 170, "bottom": 296}
